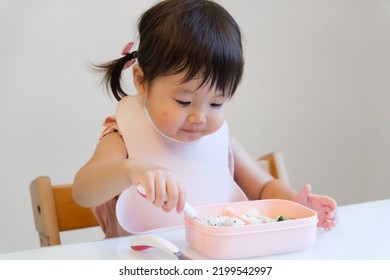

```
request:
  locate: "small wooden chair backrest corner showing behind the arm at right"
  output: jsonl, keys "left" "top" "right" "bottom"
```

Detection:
{"left": 257, "top": 152, "right": 290, "bottom": 185}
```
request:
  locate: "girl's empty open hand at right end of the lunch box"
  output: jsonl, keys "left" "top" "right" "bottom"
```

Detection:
{"left": 294, "top": 184, "right": 338, "bottom": 231}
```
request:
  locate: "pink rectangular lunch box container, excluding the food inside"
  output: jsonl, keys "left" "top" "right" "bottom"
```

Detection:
{"left": 185, "top": 199, "right": 317, "bottom": 259}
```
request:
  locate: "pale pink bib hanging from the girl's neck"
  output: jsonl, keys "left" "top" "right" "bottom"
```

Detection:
{"left": 116, "top": 96, "right": 247, "bottom": 233}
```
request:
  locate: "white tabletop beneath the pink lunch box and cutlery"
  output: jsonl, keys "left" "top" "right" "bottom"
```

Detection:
{"left": 0, "top": 199, "right": 390, "bottom": 260}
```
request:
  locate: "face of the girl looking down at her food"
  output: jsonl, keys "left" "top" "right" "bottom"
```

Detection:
{"left": 145, "top": 73, "right": 229, "bottom": 142}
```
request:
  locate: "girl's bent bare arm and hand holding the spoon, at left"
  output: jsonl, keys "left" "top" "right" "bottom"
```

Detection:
{"left": 73, "top": 132, "right": 185, "bottom": 212}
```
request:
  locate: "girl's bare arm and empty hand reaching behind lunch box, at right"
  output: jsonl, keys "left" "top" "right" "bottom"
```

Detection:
{"left": 232, "top": 137, "right": 337, "bottom": 230}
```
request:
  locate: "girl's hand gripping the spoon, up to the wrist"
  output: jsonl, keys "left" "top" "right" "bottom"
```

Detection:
{"left": 125, "top": 160, "right": 186, "bottom": 213}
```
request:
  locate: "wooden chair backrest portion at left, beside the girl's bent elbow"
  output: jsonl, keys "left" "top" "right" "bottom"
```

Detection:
{"left": 30, "top": 176, "right": 98, "bottom": 247}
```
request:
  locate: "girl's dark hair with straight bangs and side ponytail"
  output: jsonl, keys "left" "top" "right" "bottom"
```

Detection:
{"left": 98, "top": 0, "right": 244, "bottom": 100}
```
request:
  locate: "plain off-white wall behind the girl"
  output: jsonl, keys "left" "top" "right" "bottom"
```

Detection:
{"left": 0, "top": 0, "right": 390, "bottom": 252}
